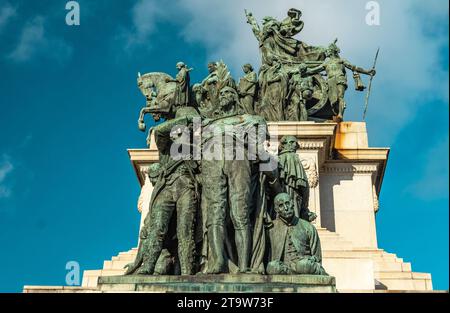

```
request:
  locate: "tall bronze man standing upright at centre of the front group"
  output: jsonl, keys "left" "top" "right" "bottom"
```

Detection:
{"left": 202, "top": 87, "right": 267, "bottom": 274}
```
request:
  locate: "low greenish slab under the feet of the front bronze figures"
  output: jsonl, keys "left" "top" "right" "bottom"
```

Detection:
{"left": 98, "top": 274, "right": 336, "bottom": 293}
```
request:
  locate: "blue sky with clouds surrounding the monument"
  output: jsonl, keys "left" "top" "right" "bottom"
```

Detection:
{"left": 0, "top": 0, "right": 449, "bottom": 292}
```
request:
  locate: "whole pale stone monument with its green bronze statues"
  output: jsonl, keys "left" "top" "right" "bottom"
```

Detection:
{"left": 24, "top": 9, "right": 432, "bottom": 292}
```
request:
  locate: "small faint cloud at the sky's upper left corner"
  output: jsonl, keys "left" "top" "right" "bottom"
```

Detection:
{"left": 8, "top": 16, "right": 72, "bottom": 63}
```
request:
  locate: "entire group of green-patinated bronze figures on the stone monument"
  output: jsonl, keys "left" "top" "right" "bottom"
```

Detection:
{"left": 126, "top": 9, "right": 375, "bottom": 275}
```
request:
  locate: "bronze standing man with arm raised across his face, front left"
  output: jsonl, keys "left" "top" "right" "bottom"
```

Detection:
{"left": 127, "top": 109, "right": 199, "bottom": 275}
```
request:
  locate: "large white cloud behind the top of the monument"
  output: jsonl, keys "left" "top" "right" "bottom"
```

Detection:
{"left": 125, "top": 0, "right": 448, "bottom": 145}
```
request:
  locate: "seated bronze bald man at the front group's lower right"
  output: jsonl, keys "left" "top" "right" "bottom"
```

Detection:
{"left": 266, "top": 193, "right": 328, "bottom": 275}
